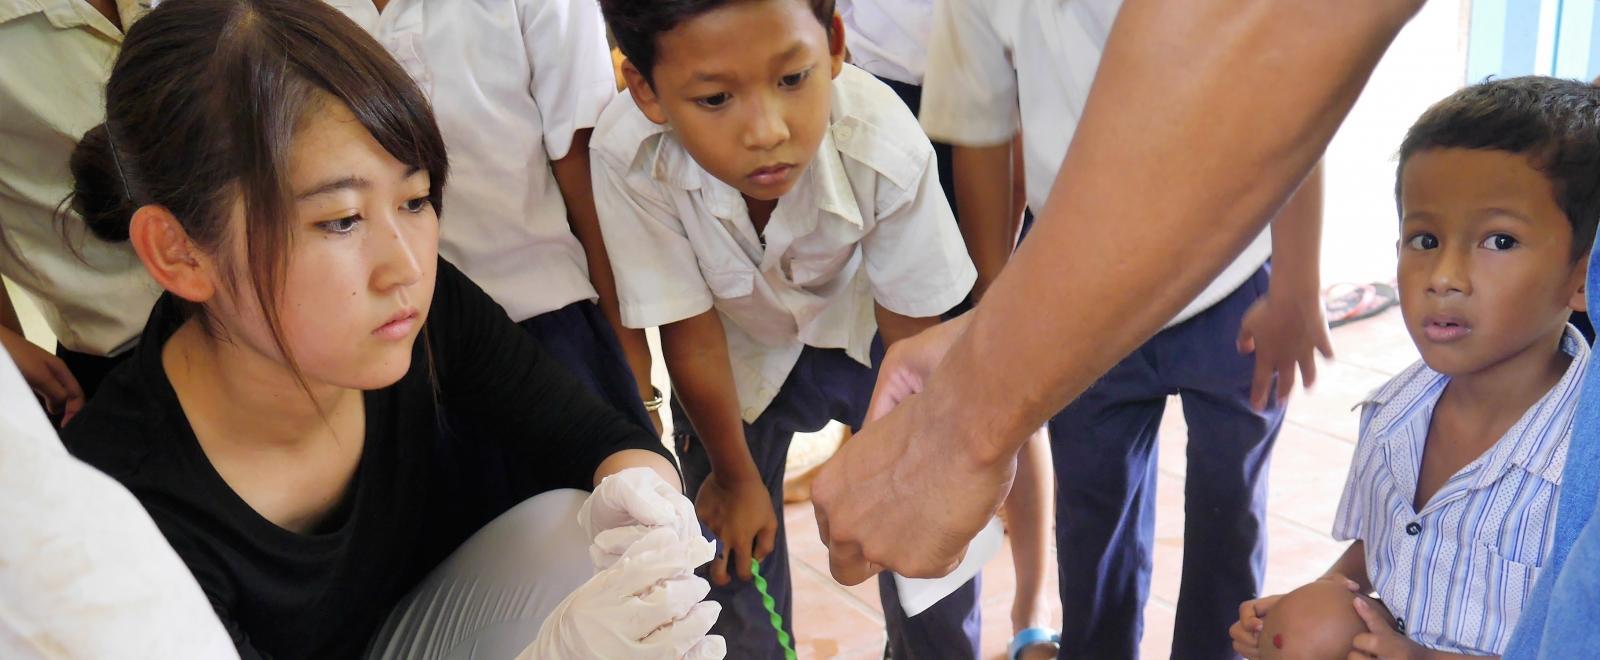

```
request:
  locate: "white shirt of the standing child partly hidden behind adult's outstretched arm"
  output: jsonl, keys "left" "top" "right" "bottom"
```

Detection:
{"left": 922, "top": 0, "right": 1272, "bottom": 325}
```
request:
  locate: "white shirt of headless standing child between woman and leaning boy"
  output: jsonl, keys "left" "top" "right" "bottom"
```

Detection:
{"left": 330, "top": 0, "right": 616, "bottom": 320}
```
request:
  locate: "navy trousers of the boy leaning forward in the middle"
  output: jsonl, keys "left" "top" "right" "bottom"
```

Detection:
{"left": 672, "top": 340, "right": 981, "bottom": 660}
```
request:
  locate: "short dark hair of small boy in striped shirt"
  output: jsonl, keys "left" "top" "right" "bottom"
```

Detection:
{"left": 1395, "top": 75, "right": 1600, "bottom": 260}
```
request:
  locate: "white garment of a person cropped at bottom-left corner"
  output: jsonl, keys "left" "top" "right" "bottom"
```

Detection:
{"left": 0, "top": 352, "right": 238, "bottom": 660}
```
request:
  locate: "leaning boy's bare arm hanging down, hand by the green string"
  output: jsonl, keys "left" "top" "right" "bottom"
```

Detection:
{"left": 661, "top": 309, "right": 778, "bottom": 585}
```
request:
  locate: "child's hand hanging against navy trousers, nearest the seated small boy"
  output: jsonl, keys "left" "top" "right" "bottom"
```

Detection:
{"left": 1238, "top": 290, "right": 1333, "bottom": 410}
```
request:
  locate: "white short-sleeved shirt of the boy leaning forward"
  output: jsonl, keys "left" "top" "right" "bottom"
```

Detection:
{"left": 590, "top": 64, "right": 978, "bottom": 421}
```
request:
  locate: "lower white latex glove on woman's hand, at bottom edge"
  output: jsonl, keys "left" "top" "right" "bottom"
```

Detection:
{"left": 518, "top": 527, "right": 728, "bottom": 660}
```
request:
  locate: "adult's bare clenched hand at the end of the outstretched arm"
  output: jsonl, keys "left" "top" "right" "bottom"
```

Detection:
{"left": 811, "top": 386, "right": 1016, "bottom": 585}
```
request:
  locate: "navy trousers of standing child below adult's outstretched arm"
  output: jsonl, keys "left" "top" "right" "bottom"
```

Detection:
{"left": 1050, "top": 266, "right": 1283, "bottom": 660}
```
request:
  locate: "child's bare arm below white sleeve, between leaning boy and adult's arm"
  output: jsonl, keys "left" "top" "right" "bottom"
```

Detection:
{"left": 950, "top": 143, "right": 1018, "bottom": 298}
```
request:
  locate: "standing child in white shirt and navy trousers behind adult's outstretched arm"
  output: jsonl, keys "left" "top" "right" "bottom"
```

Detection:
{"left": 922, "top": 0, "right": 1331, "bottom": 660}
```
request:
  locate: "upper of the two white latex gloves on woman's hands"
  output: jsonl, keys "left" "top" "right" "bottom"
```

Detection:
{"left": 578, "top": 468, "right": 709, "bottom": 570}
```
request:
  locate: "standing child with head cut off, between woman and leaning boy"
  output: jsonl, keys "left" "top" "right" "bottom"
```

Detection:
{"left": 330, "top": 0, "right": 662, "bottom": 433}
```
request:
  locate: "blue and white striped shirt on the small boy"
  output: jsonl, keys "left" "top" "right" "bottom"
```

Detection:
{"left": 1333, "top": 327, "right": 1589, "bottom": 655}
